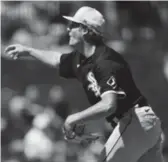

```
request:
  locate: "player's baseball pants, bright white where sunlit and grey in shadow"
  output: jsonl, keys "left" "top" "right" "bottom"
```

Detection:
{"left": 100, "top": 106, "right": 162, "bottom": 162}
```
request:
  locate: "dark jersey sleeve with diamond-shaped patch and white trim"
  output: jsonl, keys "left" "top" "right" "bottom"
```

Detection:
{"left": 96, "top": 60, "right": 126, "bottom": 98}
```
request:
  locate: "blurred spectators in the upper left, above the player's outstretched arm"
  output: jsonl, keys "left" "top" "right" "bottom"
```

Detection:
{"left": 1, "top": 1, "right": 73, "bottom": 52}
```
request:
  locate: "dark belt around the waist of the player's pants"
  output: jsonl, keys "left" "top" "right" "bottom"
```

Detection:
{"left": 110, "top": 96, "right": 149, "bottom": 128}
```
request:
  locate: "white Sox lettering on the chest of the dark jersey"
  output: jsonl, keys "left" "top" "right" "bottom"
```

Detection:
{"left": 87, "top": 71, "right": 100, "bottom": 97}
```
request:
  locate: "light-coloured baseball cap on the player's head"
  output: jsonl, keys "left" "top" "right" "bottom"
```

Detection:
{"left": 63, "top": 6, "right": 105, "bottom": 33}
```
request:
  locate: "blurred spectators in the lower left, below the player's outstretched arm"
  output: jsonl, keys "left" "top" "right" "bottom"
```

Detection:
{"left": 1, "top": 85, "right": 107, "bottom": 162}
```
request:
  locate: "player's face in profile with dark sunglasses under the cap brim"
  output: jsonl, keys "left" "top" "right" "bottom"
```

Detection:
{"left": 68, "top": 22, "right": 82, "bottom": 46}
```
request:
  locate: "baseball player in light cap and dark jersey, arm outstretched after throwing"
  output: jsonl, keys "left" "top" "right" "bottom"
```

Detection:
{"left": 5, "top": 6, "right": 162, "bottom": 162}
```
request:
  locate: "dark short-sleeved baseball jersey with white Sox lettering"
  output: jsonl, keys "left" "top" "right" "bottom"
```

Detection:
{"left": 59, "top": 45, "right": 141, "bottom": 121}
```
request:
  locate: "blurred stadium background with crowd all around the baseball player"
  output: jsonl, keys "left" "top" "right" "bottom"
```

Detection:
{"left": 1, "top": 1, "right": 168, "bottom": 162}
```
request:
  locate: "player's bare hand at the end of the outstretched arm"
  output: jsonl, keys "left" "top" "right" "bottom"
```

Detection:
{"left": 4, "top": 44, "right": 28, "bottom": 60}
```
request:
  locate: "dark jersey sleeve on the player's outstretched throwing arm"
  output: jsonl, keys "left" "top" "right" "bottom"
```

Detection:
{"left": 59, "top": 52, "right": 75, "bottom": 78}
